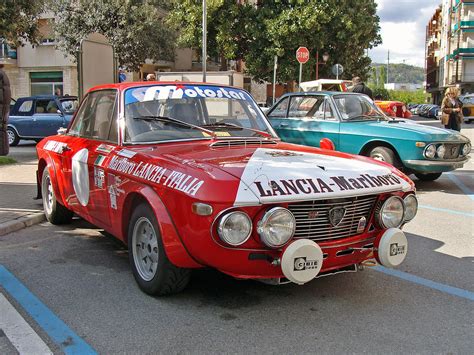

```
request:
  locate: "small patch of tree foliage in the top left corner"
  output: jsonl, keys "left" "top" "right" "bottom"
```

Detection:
{"left": 0, "top": 0, "right": 44, "bottom": 46}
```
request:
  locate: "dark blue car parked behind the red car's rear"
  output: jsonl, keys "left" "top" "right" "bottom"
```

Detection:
{"left": 7, "top": 95, "right": 77, "bottom": 146}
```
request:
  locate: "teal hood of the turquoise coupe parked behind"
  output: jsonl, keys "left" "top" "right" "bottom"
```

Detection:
{"left": 363, "top": 120, "right": 469, "bottom": 142}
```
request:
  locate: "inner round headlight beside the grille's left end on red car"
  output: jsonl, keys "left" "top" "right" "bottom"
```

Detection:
{"left": 257, "top": 207, "right": 296, "bottom": 248}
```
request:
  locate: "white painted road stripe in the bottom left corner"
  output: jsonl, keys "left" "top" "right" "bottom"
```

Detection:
{"left": 0, "top": 293, "right": 52, "bottom": 354}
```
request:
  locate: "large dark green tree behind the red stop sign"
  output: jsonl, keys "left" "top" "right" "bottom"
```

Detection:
{"left": 168, "top": 0, "right": 381, "bottom": 82}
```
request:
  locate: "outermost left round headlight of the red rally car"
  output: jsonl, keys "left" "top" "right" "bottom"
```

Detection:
{"left": 217, "top": 211, "right": 252, "bottom": 246}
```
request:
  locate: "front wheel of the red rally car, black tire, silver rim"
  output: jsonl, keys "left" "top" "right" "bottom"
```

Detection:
{"left": 128, "top": 203, "right": 191, "bottom": 296}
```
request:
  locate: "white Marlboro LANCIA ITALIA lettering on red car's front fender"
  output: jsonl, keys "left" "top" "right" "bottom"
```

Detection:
{"left": 108, "top": 156, "right": 204, "bottom": 196}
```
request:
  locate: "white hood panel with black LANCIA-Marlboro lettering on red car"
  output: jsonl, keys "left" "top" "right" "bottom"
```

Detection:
{"left": 234, "top": 148, "right": 411, "bottom": 206}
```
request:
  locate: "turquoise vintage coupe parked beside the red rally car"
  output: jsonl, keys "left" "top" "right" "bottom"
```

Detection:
{"left": 267, "top": 92, "right": 471, "bottom": 180}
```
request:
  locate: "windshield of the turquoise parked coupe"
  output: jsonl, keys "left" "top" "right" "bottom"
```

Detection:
{"left": 334, "top": 94, "right": 387, "bottom": 121}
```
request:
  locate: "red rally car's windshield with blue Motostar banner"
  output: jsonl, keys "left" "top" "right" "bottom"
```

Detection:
{"left": 124, "top": 84, "right": 276, "bottom": 143}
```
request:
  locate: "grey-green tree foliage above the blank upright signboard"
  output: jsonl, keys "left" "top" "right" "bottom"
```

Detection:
{"left": 52, "top": 0, "right": 174, "bottom": 70}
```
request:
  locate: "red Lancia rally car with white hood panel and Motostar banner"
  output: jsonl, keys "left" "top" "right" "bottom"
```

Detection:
{"left": 37, "top": 82, "right": 417, "bottom": 295}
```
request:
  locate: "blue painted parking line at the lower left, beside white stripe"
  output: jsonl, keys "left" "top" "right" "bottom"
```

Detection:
{"left": 0, "top": 265, "right": 97, "bottom": 355}
